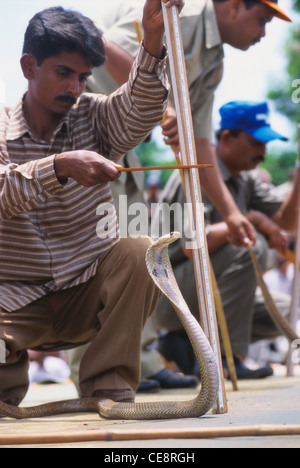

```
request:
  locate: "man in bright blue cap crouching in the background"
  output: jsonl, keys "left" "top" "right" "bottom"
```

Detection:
{"left": 157, "top": 102, "right": 300, "bottom": 379}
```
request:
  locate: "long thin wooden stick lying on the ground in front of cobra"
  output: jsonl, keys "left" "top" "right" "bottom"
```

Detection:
{"left": 0, "top": 425, "right": 300, "bottom": 446}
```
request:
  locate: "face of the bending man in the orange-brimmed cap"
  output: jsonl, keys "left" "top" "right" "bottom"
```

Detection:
{"left": 229, "top": 1, "right": 274, "bottom": 51}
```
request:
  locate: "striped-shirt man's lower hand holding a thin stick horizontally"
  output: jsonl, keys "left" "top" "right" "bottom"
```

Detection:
{"left": 54, "top": 150, "right": 120, "bottom": 187}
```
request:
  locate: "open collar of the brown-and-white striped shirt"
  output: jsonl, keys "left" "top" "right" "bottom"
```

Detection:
{"left": 6, "top": 93, "right": 70, "bottom": 141}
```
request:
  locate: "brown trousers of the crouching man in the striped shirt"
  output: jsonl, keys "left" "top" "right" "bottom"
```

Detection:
{"left": 0, "top": 238, "right": 159, "bottom": 405}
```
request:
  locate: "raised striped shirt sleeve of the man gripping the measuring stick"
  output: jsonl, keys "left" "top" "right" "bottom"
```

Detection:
{"left": 90, "top": 46, "right": 169, "bottom": 162}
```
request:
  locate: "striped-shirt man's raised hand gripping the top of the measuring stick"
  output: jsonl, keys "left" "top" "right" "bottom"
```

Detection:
{"left": 143, "top": 0, "right": 184, "bottom": 58}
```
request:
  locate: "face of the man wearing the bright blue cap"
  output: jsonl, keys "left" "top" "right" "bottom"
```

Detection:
{"left": 222, "top": 132, "right": 266, "bottom": 175}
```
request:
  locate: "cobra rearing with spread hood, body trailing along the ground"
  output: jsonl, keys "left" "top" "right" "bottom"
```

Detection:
{"left": 0, "top": 233, "right": 219, "bottom": 420}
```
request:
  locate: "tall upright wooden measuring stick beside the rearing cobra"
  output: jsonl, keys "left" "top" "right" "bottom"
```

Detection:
{"left": 162, "top": 4, "right": 228, "bottom": 414}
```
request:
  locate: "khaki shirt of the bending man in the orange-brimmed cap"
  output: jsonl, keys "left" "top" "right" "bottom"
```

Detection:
{"left": 91, "top": 0, "right": 224, "bottom": 139}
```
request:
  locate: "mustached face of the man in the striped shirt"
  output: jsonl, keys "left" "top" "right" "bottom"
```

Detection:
{"left": 29, "top": 51, "right": 92, "bottom": 115}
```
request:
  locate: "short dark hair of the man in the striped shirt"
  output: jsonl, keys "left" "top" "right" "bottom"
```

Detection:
{"left": 23, "top": 7, "right": 106, "bottom": 67}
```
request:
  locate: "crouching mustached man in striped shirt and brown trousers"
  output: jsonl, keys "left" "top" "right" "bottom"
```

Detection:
{"left": 0, "top": 0, "right": 183, "bottom": 405}
